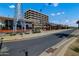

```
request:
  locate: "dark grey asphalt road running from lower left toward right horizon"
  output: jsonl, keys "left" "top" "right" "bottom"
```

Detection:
{"left": 4, "top": 30, "right": 74, "bottom": 56}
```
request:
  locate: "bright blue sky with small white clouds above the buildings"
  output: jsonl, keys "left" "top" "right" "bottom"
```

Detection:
{"left": 0, "top": 3, "right": 79, "bottom": 26}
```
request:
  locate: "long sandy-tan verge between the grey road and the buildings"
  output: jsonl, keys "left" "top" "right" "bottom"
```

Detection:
{"left": 0, "top": 29, "right": 70, "bottom": 42}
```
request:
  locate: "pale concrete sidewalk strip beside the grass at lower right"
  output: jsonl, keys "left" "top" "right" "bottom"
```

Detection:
{"left": 52, "top": 37, "right": 77, "bottom": 56}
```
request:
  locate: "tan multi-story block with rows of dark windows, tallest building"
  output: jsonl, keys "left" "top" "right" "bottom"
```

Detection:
{"left": 24, "top": 10, "right": 48, "bottom": 28}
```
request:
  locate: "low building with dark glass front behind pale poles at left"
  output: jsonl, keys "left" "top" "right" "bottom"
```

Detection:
{"left": 0, "top": 16, "right": 32, "bottom": 32}
